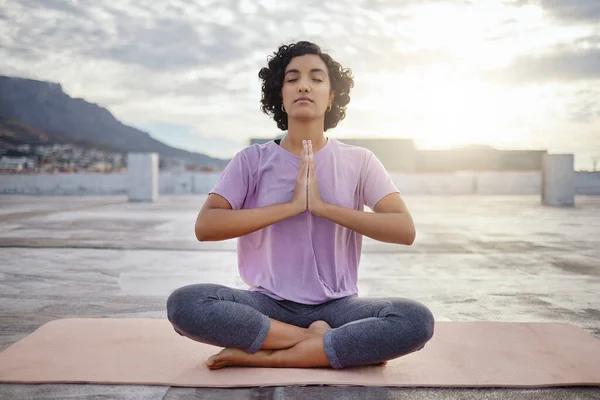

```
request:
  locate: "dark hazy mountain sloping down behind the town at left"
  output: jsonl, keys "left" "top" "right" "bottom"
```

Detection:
{"left": 0, "top": 76, "right": 229, "bottom": 168}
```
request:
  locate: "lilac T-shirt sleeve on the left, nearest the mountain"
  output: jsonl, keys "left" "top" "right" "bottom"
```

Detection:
{"left": 208, "top": 151, "right": 249, "bottom": 210}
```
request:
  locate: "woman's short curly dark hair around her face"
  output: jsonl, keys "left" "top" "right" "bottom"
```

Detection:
{"left": 258, "top": 41, "right": 354, "bottom": 131}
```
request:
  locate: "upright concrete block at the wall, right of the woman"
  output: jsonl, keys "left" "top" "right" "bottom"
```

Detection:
{"left": 542, "top": 154, "right": 575, "bottom": 207}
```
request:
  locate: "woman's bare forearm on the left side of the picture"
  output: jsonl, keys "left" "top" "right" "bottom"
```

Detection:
{"left": 195, "top": 203, "right": 298, "bottom": 242}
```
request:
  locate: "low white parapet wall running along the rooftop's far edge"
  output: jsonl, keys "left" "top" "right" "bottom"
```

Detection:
{"left": 0, "top": 172, "right": 600, "bottom": 196}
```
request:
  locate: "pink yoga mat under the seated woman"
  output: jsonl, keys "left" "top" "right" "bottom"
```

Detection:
{"left": 0, "top": 318, "right": 600, "bottom": 388}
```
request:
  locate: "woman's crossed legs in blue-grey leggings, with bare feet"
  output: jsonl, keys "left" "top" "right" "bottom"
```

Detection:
{"left": 167, "top": 284, "right": 433, "bottom": 369}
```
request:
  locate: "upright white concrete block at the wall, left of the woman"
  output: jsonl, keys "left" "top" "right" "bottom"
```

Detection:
{"left": 127, "top": 153, "right": 158, "bottom": 202}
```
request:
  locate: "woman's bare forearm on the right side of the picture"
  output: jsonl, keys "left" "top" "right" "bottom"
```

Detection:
{"left": 315, "top": 203, "right": 416, "bottom": 245}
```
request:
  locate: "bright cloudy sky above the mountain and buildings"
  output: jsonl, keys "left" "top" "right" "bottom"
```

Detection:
{"left": 0, "top": 0, "right": 600, "bottom": 169}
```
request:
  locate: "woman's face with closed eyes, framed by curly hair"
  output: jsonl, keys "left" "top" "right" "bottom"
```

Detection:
{"left": 281, "top": 54, "right": 333, "bottom": 119}
